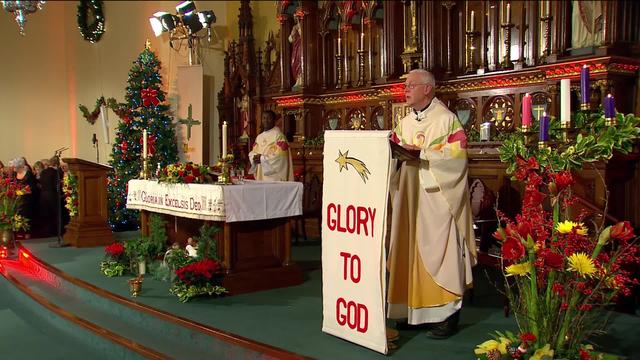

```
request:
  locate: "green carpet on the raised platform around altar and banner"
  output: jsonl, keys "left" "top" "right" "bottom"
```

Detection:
{"left": 12, "top": 233, "right": 640, "bottom": 360}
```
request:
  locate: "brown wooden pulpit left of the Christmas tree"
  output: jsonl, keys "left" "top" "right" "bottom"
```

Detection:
{"left": 62, "top": 158, "right": 113, "bottom": 247}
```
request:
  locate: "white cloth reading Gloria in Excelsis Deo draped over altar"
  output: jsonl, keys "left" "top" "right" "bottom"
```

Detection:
{"left": 127, "top": 180, "right": 303, "bottom": 222}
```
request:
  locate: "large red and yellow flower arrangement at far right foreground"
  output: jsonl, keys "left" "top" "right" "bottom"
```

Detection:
{"left": 475, "top": 157, "right": 640, "bottom": 359}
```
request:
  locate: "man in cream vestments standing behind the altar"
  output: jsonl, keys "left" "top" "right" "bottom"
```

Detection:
{"left": 249, "top": 110, "right": 293, "bottom": 181}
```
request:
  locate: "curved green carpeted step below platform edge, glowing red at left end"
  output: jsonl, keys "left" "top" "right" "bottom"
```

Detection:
{"left": 5, "top": 255, "right": 292, "bottom": 359}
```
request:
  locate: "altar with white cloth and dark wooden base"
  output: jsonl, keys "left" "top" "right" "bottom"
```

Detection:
{"left": 127, "top": 180, "right": 303, "bottom": 295}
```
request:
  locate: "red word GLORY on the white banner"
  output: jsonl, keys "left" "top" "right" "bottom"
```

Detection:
{"left": 327, "top": 203, "right": 376, "bottom": 237}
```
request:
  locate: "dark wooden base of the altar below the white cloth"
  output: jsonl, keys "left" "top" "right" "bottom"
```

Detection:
{"left": 142, "top": 211, "right": 303, "bottom": 295}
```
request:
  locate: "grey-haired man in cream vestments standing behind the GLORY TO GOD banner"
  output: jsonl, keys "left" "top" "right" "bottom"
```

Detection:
{"left": 387, "top": 70, "right": 476, "bottom": 339}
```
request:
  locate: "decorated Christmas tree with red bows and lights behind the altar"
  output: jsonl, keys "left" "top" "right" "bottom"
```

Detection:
{"left": 107, "top": 43, "right": 178, "bottom": 231}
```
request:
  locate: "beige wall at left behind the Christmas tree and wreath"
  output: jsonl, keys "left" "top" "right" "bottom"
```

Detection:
{"left": 0, "top": 1, "right": 238, "bottom": 164}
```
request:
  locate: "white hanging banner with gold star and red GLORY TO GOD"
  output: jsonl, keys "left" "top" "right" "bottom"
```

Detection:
{"left": 322, "top": 130, "right": 391, "bottom": 354}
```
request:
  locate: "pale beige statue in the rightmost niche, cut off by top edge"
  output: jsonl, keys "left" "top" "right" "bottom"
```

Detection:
{"left": 571, "top": 0, "right": 603, "bottom": 49}
